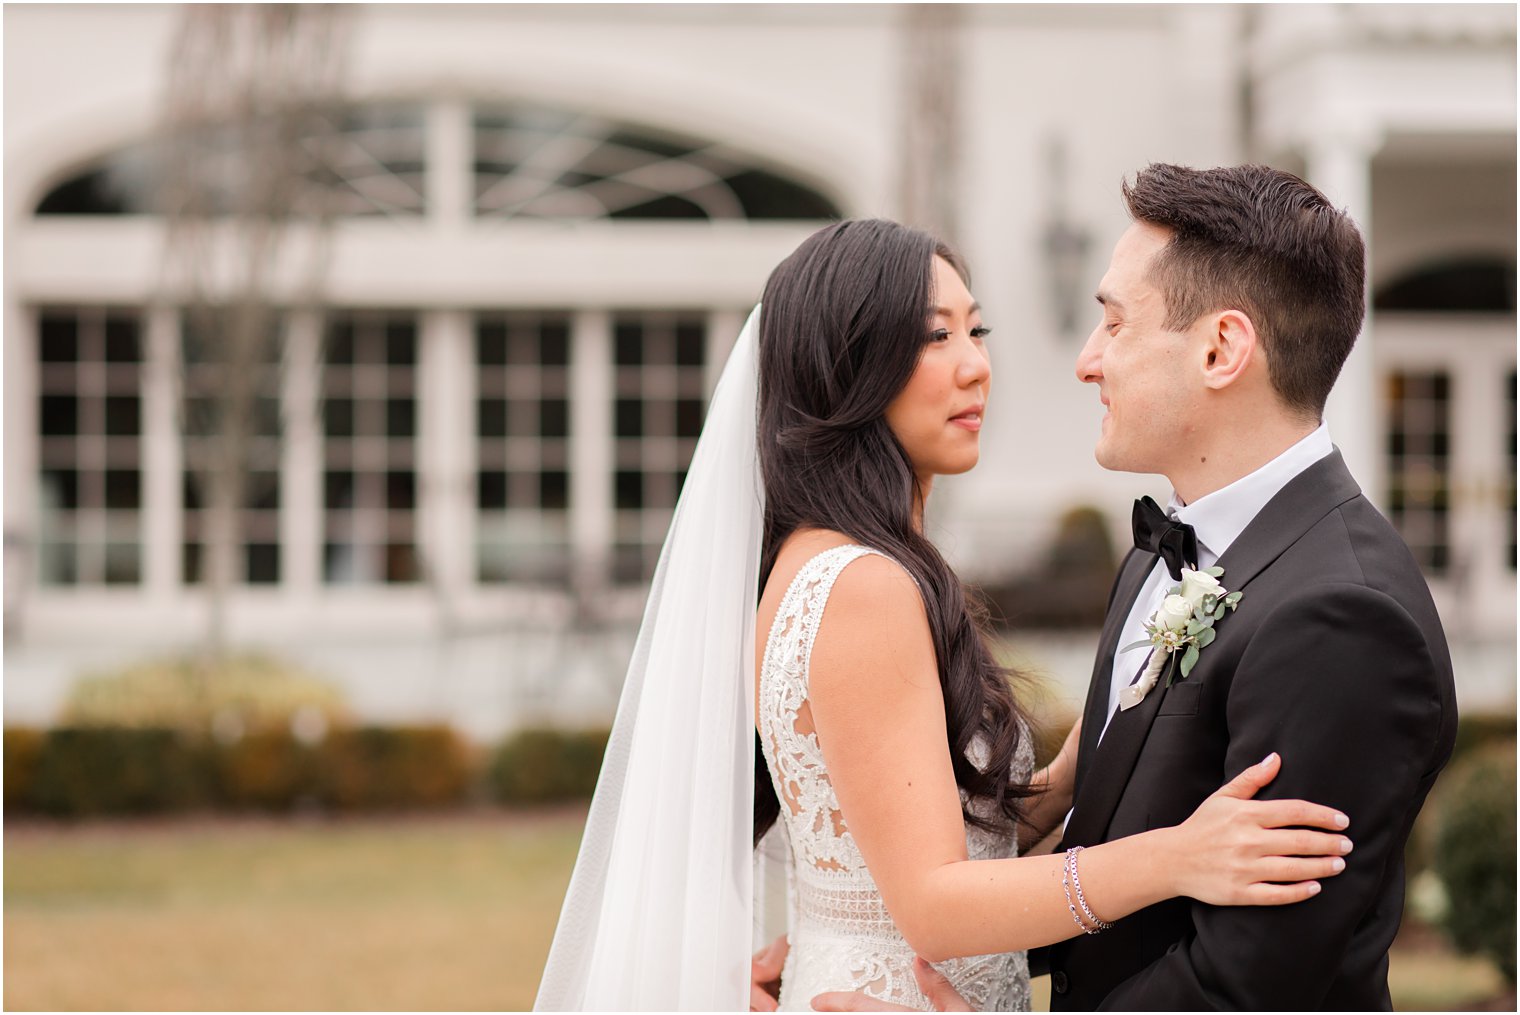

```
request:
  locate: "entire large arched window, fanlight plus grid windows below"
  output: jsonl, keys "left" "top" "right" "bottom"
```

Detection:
{"left": 27, "top": 97, "right": 842, "bottom": 597}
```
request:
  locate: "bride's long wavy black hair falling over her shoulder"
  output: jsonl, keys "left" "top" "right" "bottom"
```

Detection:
{"left": 755, "top": 219, "right": 1029, "bottom": 843}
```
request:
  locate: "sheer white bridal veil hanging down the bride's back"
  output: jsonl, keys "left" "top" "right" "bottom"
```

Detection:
{"left": 534, "top": 307, "right": 765, "bottom": 1010}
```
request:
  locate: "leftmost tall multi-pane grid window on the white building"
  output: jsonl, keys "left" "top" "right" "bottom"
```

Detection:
{"left": 36, "top": 307, "right": 143, "bottom": 585}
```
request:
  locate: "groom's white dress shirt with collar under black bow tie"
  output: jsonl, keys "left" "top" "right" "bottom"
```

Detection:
{"left": 1099, "top": 422, "right": 1335, "bottom": 738}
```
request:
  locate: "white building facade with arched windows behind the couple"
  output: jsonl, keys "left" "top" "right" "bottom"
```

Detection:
{"left": 3, "top": 5, "right": 1515, "bottom": 735}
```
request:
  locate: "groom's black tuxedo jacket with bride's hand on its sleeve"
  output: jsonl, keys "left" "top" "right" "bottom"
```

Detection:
{"left": 1047, "top": 451, "right": 1456, "bottom": 1010}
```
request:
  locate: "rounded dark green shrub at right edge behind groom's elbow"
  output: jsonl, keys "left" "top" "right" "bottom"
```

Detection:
{"left": 1433, "top": 740, "right": 1515, "bottom": 983}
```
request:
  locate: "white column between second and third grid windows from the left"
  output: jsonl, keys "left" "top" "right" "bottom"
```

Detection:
{"left": 280, "top": 310, "right": 324, "bottom": 602}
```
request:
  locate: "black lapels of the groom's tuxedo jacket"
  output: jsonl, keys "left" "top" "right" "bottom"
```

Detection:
{"left": 1064, "top": 451, "right": 1362, "bottom": 846}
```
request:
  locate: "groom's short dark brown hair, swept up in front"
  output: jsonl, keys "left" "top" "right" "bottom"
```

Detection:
{"left": 1123, "top": 163, "right": 1366, "bottom": 419}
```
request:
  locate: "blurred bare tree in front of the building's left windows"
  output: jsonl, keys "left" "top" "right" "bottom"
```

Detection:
{"left": 160, "top": 5, "right": 345, "bottom": 661}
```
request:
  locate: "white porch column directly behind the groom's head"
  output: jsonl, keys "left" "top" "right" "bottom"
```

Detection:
{"left": 1306, "top": 131, "right": 1386, "bottom": 506}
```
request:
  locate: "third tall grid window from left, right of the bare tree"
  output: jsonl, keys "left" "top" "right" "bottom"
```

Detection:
{"left": 322, "top": 311, "right": 421, "bottom": 585}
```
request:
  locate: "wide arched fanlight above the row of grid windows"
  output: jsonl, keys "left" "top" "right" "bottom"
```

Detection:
{"left": 36, "top": 103, "right": 841, "bottom": 220}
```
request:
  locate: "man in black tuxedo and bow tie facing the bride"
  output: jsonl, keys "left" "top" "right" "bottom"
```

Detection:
{"left": 802, "top": 166, "right": 1456, "bottom": 1010}
